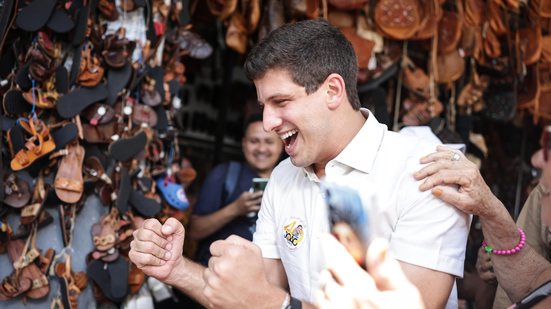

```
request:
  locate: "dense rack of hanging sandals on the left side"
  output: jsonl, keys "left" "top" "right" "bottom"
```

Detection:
{"left": 0, "top": 0, "right": 205, "bottom": 308}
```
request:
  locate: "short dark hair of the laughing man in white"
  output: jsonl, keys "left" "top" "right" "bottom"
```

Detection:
{"left": 245, "top": 19, "right": 361, "bottom": 110}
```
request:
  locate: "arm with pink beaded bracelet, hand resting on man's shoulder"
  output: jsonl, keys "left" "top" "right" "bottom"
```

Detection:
{"left": 414, "top": 146, "right": 551, "bottom": 302}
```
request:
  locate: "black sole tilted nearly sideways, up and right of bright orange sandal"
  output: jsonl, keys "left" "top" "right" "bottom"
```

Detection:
{"left": 56, "top": 83, "right": 107, "bottom": 119}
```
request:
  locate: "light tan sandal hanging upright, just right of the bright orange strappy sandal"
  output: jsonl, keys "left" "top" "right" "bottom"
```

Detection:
{"left": 54, "top": 144, "right": 85, "bottom": 204}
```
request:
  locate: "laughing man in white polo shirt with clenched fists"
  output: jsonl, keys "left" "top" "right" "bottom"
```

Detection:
{"left": 130, "top": 20, "right": 469, "bottom": 309}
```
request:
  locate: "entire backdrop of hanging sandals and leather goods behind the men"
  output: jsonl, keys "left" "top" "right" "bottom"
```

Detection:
{"left": 0, "top": 0, "right": 551, "bottom": 308}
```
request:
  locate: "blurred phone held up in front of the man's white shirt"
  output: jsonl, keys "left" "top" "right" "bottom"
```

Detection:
{"left": 322, "top": 181, "right": 371, "bottom": 269}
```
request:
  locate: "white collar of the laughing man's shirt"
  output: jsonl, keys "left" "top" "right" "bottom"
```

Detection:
{"left": 303, "top": 108, "right": 386, "bottom": 181}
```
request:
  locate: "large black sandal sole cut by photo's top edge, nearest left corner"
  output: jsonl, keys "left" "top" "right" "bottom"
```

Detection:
{"left": 15, "top": 0, "right": 57, "bottom": 32}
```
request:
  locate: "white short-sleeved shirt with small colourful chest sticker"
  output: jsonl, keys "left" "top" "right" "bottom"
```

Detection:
{"left": 254, "top": 109, "right": 470, "bottom": 305}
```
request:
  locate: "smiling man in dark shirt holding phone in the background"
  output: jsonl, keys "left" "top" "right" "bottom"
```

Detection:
{"left": 188, "top": 114, "right": 283, "bottom": 265}
